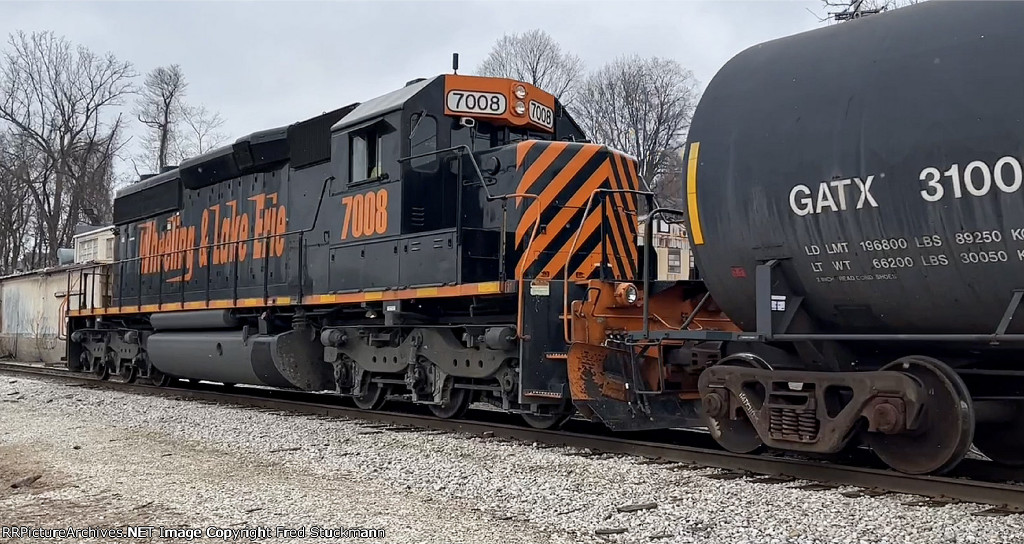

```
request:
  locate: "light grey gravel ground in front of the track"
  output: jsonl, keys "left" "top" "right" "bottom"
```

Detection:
{"left": 0, "top": 374, "right": 1024, "bottom": 544}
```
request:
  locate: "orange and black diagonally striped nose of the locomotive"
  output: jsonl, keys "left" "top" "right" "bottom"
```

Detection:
{"left": 515, "top": 140, "right": 640, "bottom": 281}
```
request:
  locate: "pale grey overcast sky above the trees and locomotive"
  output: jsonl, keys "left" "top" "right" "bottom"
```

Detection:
{"left": 0, "top": 0, "right": 823, "bottom": 175}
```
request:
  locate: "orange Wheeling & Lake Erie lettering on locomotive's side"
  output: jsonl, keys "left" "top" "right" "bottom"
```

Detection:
{"left": 138, "top": 193, "right": 288, "bottom": 282}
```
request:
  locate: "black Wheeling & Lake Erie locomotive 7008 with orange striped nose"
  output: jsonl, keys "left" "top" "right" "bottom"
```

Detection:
{"left": 68, "top": 74, "right": 716, "bottom": 427}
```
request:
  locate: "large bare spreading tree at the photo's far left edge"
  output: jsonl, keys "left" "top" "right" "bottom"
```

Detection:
{"left": 0, "top": 32, "right": 135, "bottom": 266}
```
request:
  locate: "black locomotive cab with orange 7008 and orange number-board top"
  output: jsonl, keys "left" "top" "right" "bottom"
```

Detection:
{"left": 329, "top": 75, "right": 583, "bottom": 291}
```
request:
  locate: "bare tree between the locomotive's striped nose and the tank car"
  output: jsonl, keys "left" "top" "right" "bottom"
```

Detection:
{"left": 577, "top": 55, "right": 698, "bottom": 207}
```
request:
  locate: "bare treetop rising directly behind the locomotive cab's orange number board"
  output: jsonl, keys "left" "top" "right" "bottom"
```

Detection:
{"left": 476, "top": 30, "right": 584, "bottom": 107}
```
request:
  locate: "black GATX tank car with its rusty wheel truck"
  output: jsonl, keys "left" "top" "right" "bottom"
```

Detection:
{"left": 568, "top": 2, "right": 1024, "bottom": 473}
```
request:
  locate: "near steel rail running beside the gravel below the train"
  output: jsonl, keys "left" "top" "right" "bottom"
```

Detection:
{"left": 6, "top": 362, "right": 1024, "bottom": 510}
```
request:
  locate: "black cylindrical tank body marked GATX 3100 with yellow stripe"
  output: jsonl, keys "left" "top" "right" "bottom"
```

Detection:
{"left": 685, "top": 1, "right": 1024, "bottom": 334}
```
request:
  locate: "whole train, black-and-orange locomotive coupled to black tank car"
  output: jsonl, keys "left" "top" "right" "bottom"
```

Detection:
{"left": 68, "top": 1, "right": 1024, "bottom": 473}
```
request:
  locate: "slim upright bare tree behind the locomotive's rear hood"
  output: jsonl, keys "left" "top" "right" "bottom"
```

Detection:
{"left": 135, "top": 65, "right": 188, "bottom": 171}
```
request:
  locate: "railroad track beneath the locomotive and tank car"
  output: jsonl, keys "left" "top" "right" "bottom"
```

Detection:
{"left": 0, "top": 362, "right": 1024, "bottom": 515}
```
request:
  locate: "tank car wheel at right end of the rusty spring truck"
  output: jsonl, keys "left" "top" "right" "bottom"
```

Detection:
{"left": 863, "top": 355, "right": 974, "bottom": 474}
